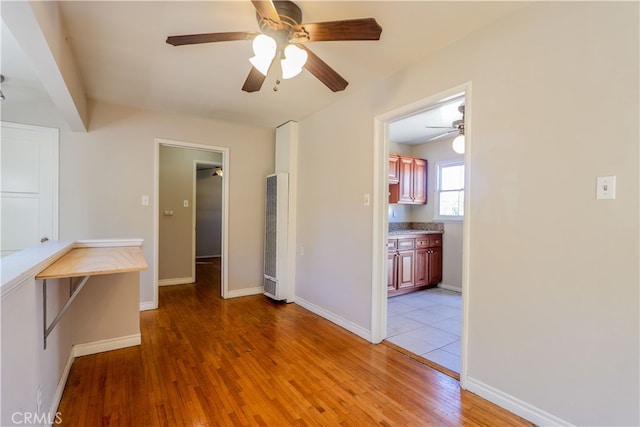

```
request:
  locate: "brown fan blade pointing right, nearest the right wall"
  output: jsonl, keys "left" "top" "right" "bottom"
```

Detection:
{"left": 292, "top": 18, "right": 382, "bottom": 42}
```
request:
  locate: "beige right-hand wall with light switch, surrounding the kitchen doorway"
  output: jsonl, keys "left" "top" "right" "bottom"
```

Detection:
{"left": 297, "top": 2, "right": 640, "bottom": 425}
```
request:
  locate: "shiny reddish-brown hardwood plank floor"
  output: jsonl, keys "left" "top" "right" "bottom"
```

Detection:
{"left": 58, "top": 263, "right": 531, "bottom": 426}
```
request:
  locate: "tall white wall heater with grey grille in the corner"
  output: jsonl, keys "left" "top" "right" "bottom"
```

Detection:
{"left": 264, "top": 173, "right": 293, "bottom": 301}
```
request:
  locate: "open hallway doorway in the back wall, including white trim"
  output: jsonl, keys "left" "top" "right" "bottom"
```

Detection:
{"left": 154, "top": 139, "right": 229, "bottom": 307}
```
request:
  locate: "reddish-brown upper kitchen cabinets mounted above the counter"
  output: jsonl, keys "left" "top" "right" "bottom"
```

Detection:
{"left": 389, "top": 154, "right": 427, "bottom": 205}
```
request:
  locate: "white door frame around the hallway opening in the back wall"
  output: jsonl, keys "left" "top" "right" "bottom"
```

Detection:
{"left": 153, "top": 138, "right": 230, "bottom": 308}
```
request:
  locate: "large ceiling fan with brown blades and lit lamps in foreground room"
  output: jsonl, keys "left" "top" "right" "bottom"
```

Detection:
{"left": 167, "top": 0, "right": 382, "bottom": 92}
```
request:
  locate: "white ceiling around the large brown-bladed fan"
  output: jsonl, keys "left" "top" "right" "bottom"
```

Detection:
{"left": 0, "top": 0, "right": 526, "bottom": 132}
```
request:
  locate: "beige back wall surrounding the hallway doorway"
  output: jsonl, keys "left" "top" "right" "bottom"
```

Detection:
{"left": 2, "top": 103, "right": 275, "bottom": 307}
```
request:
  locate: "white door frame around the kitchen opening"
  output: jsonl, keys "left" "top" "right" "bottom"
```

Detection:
{"left": 371, "top": 82, "right": 473, "bottom": 388}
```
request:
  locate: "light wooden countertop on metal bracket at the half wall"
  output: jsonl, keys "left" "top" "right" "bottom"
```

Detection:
{"left": 36, "top": 246, "right": 148, "bottom": 280}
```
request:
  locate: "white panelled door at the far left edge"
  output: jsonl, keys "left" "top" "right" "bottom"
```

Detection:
{"left": 0, "top": 122, "right": 58, "bottom": 256}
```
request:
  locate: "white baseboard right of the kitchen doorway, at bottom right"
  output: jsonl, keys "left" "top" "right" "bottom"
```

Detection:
{"left": 465, "top": 377, "right": 573, "bottom": 427}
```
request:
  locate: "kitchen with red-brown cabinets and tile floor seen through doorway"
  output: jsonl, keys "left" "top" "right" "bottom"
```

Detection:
{"left": 386, "top": 94, "right": 464, "bottom": 377}
